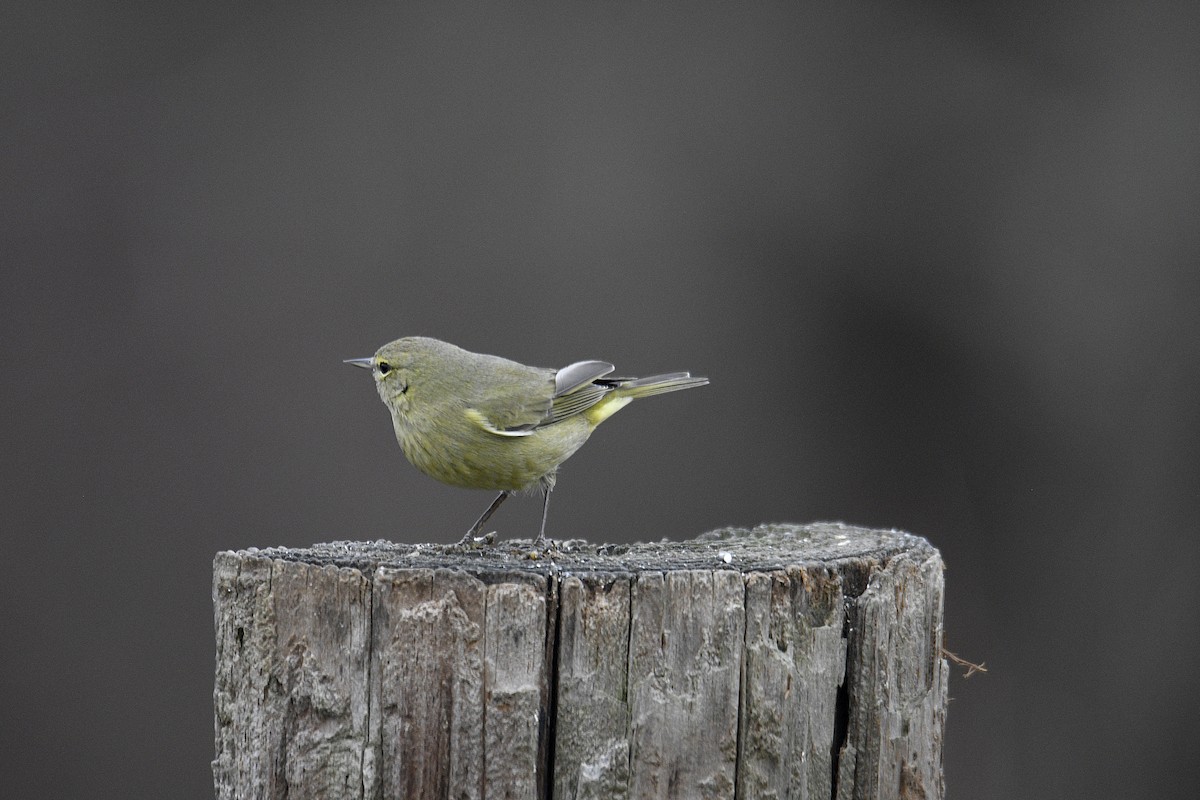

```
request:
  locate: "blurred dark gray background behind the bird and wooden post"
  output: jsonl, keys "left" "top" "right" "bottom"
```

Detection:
{"left": 0, "top": 1, "right": 1200, "bottom": 799}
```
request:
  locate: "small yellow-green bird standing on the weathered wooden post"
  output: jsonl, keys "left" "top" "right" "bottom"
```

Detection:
{"left": 346, "top": 336, "right": 708, "bottom": 546}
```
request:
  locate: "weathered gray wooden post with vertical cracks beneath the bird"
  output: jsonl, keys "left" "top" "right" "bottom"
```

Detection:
{"left": 212, "top": 524, "right": 947, "bottom": 800}
